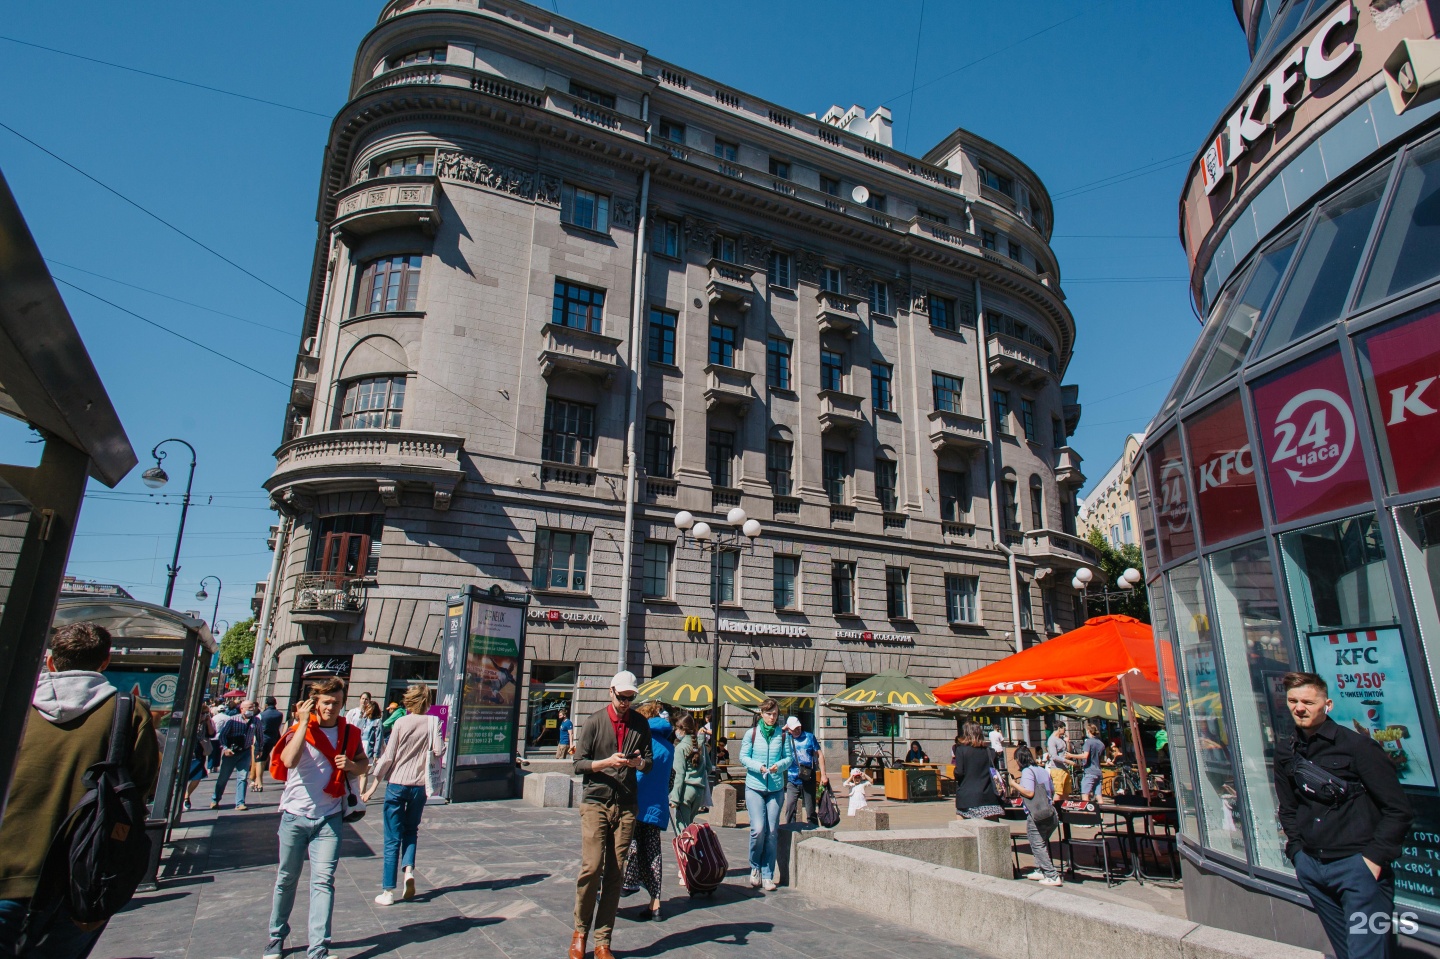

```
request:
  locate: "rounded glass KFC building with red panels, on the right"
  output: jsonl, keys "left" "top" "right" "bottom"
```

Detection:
{"left": 1133, "top": 0, "right": 1440, "bottom": 947}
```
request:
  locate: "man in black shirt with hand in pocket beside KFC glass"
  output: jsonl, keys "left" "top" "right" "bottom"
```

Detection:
{"left": 1274, "top": 672, "right": 1414, "bottom": 959}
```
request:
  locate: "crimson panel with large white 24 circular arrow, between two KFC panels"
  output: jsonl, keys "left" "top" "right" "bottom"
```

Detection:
{"left": 1254, "top": 348, "right": 1371, "bottom": 523}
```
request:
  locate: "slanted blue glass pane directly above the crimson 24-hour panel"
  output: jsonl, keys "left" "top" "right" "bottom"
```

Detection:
{"left": 1263, "top": 170, "right": 1387, "bottom": 353}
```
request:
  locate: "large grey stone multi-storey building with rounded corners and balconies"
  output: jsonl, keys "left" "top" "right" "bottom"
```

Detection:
{"left": 264, "top": 0, "right": 1090, "bottom": 750}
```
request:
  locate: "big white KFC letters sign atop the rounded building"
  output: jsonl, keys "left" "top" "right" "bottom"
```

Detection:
{"left": 1200, "top": 3, "right": 1359, "bottom": 194}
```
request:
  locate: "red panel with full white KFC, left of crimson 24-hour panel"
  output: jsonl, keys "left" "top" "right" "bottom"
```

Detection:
{"left": 1185, "top": 392, "right": 1261, "bottom": 543}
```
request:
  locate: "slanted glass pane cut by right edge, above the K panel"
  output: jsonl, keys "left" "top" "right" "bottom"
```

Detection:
{"left": 1359, "top": 138, "right": 1440, "bottom": 307}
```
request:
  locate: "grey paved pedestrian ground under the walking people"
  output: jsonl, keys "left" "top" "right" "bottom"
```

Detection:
{"left": 92, "top": 786, "right": 982, "bottom": 959}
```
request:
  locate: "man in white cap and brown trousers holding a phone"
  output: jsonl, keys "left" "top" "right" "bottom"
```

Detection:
{"left": 569, "top": 670, "right": 651, "bottom": 959}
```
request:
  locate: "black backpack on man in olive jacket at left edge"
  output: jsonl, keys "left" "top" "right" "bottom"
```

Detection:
{"left": 19, "top": 693, "right": 150, "bottom": 938}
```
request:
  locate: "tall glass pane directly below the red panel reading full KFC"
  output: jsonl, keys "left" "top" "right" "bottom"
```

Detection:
{"left": 1210, "top": 540, "right": 1296, "bottom": 873}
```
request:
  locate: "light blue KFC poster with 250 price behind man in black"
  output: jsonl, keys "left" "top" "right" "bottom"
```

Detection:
{"left": 1310, "top": 626, "right": 1436, "bottom": 786}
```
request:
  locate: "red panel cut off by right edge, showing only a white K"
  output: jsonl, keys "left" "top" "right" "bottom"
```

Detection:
{"left": 1359, "top": 306, "right": 1440, "bottom": 492}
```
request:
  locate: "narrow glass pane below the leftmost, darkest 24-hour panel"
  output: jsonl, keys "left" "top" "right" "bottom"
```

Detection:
{"left": 1166, "top": 562, "right": 1246, "bottom": 863}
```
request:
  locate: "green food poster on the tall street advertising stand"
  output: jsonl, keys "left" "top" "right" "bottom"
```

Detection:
{"left": 455, "top": 600, "right": 526, "bottom": 766}
